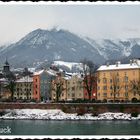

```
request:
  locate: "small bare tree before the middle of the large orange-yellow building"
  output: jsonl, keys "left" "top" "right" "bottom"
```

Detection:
{"left": 110, "top": 73, "right": 122, "bottom": 102}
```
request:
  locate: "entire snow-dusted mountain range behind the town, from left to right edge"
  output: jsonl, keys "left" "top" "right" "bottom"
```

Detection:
{"left": 0, "top": 29, "right": 140, "bottom": 67}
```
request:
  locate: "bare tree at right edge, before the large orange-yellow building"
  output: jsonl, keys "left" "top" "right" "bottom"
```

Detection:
{"left": 130, "top": 80, "right": 140, "bottom": 100}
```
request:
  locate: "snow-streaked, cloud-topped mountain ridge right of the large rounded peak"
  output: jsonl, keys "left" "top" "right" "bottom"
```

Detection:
{"left": 84, "top": 37, "right": 140, "bottom": 60}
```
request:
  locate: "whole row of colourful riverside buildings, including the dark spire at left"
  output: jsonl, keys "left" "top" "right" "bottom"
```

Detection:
{"left": 0, "top": 59, "right": 140, "bottom": 102}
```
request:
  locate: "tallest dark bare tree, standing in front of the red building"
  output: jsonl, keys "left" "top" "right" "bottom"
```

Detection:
{"left": 81, "top": 59, "right": 97, "bottom": 100}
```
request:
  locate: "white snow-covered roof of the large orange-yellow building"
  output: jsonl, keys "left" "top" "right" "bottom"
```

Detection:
{"left": 97, "top": 63, "right": 140, "bottom": 71}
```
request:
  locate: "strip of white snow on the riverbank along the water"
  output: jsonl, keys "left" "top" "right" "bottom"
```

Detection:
{"left": 0, "top": 109, "right": 140, "bottom": 120}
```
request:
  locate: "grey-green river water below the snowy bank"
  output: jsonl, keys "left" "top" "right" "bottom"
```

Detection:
{"left": 0, "top": 120, "right": 140, "bottom": 135}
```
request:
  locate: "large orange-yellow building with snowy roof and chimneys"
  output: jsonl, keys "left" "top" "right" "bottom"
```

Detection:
{"left": 97, "top": 60, "right": 140, "bottom": 101}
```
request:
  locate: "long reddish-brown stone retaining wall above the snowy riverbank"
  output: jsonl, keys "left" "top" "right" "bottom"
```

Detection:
{"left": 0, "top": 103, "right": 140, "bottom": 113}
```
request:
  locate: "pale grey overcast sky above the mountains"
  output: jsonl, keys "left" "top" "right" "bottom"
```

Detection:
{"left": 0, "top": 4, "right": 140, "bottom": 44}
